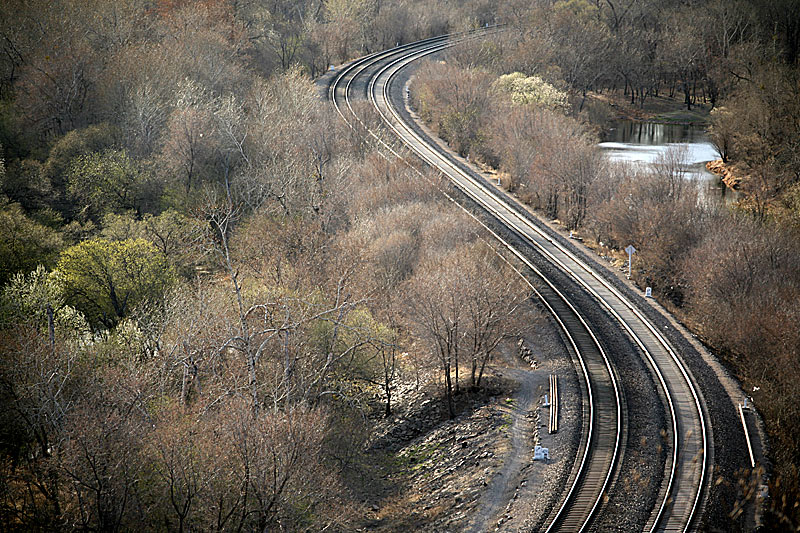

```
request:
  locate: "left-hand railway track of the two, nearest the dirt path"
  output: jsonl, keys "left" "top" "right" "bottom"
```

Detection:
{"left": 331, "top": 34, "right": 622, "bottom": 531}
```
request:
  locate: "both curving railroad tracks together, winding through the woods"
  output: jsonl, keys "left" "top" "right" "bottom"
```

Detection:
{"left": 329, "top": 32, "right": 710, "bottom": 531}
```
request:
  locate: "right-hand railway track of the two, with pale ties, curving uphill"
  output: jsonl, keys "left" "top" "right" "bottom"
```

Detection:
{"left": 362, "top": 37, "right": 708, "bottom": 531}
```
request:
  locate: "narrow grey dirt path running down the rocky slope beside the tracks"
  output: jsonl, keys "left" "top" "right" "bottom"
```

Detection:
{"left": 468, "top": 368, "right": 541, "bottom": 533}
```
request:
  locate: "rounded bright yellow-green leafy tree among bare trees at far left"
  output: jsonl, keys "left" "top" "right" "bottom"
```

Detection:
{"left": 56, "top": 239, "right": 174, "bottom": 328}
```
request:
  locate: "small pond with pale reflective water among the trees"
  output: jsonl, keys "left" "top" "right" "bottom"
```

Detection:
{"left": 599, "top": 120, "right": 735, "bottom": 201}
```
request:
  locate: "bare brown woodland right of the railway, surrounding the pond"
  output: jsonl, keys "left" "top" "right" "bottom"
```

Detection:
{"left": 412, "top": 1, "right": 800, "bottom": 530}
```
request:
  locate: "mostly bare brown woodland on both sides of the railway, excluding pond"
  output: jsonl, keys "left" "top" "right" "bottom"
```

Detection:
{"left": 0, "top": 0, "right": 800, "bottom": 531}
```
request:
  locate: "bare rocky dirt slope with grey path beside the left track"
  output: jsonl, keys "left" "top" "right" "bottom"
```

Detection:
{"left": 359, "top": 306, "right": 581, "bottom": 533}
